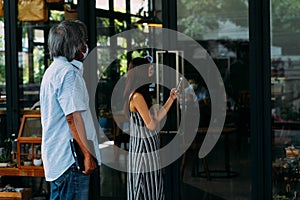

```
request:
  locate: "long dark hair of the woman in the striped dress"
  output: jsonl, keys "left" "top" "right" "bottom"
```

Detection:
{"left": 123, "top": 57, "right": 152, "bottom": 116}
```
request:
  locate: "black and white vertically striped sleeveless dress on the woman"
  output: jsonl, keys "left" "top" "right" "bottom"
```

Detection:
{"left": 127, "top": 112, "right": 164, "bottom": 200}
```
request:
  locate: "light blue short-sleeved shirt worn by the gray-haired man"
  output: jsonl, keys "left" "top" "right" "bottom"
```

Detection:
{"left": 40, "top": 57, "right": 101, "bottom": 181}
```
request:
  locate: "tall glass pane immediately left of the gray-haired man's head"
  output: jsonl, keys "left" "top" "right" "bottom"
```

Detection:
{"left": 18, "top": 22, "right": 48, "bottom": 109}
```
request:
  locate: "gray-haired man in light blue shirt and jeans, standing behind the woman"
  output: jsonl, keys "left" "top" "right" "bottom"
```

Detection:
{"left": 40, "top": 21, "right": 101, "bottom": 200}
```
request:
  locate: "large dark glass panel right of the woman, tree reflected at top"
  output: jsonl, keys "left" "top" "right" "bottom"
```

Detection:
{"left": 177, "top": 0, "right": 251, "bottom": 199}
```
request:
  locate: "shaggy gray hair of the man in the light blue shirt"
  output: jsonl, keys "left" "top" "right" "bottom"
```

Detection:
{"left": 48, "top": 20, "right": 86, "bottom": 61}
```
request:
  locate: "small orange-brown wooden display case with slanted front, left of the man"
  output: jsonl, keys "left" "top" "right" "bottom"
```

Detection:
{"left": 17, "top": 114, "right": 42, "bottom": 168}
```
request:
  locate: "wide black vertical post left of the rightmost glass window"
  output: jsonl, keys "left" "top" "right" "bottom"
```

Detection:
{"left": 249, "top": 0, "right": 272, "bottom": 199}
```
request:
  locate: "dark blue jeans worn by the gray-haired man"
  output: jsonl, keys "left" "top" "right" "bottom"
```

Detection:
{"left": 50, "top": 165, "right": 90, "bottom": 200}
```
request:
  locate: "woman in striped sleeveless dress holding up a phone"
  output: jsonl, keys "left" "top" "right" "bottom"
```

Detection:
{"left": 124, "top": 58, "right": 177, "bottom": 200}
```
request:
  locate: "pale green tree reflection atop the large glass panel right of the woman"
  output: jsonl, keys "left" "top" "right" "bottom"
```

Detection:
{"left": 178, "top": 0, "right": 248, "bottom": 39}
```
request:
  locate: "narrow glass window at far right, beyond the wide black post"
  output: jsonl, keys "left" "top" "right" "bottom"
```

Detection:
{"left": 270, "top": 0, "right": 300, "bottom": 199}
